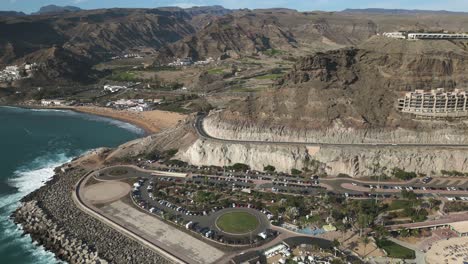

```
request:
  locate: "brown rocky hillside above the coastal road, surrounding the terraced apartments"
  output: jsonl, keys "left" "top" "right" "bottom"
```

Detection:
{"left": 206, "top": 37, "right": 468, "bottom": 143}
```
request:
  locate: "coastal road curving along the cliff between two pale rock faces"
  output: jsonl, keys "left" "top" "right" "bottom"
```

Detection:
{"left": 194, "top": 114, "right": 468, "bottom": 148}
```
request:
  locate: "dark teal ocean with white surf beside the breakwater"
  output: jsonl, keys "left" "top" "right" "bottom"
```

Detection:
{"left": 0, "top": 107, "right": 144, "bottom": 264}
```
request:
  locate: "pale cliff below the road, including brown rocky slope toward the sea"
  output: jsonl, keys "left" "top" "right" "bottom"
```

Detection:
{"left": 102, "top": 117, "right": 468, "bottom": 177}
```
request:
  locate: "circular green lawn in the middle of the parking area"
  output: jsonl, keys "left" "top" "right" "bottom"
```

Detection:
{"left": 216, "top": 212, "right": 260, "bottom": 234}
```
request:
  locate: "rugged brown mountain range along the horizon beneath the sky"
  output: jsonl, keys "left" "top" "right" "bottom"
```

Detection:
{"left": 0, "top": 6, "right": 468, "bottom": 82}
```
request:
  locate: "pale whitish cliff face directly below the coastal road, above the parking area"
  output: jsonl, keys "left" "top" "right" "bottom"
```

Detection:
{"left": 177, "top": 140, "right": 468, "bottom": 177}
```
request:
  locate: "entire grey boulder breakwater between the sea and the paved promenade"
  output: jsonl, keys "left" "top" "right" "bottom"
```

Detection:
{"left": 12, "top": 164, "right": 170, "bottom": 264}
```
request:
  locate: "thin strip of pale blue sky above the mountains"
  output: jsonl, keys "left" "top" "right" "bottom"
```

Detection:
{"left": 0, "top": 0, "right": 468, "bottom": 13}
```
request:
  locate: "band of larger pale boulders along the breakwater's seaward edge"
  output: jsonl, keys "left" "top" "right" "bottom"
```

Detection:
{"left": 14, "top": 201, "right": 108, "bottom": 263}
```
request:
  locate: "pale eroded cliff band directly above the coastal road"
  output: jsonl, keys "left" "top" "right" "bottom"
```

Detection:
{"left": 204, "top": 113, "right": 468, "bottom": 144}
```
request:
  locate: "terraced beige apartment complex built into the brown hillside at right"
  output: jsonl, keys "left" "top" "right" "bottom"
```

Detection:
{"left": 398, "top": 88, "right": 468, "bottom": 117}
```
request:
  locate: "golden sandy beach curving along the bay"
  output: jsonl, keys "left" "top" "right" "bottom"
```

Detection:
{"left": 52, "top": 106, "right": 186, "bottom": 134}
